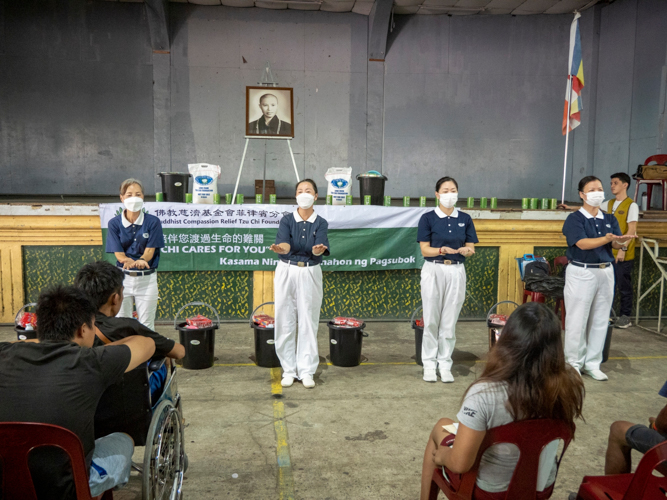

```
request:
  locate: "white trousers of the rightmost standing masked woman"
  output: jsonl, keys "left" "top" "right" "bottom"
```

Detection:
{"left": 564, "top": 264, "right": 614, "bottom": 370}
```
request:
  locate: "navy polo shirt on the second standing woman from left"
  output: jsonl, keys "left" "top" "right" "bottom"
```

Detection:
{"left": 276, "top": 210, "right": 330, "bottom": 265}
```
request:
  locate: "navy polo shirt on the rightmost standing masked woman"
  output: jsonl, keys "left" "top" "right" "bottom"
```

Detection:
{"left": 563, "top": 208, "right": 623, "bottom": 264}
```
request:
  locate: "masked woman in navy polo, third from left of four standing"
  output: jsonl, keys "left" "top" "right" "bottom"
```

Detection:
{"left": 417, "top": 177, "right": 479, "bottom": 382}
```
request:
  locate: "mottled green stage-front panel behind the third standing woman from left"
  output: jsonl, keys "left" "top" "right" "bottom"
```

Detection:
{"left": 321, "top": 247, "right": 499, "bottom": 320}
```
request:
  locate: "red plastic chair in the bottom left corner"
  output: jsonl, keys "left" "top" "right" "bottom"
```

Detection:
{"left": 0, "top": 422, "right": 113, "bottom": 500}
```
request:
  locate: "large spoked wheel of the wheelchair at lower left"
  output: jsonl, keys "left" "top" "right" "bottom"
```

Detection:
{"left": 142, "top": 400, "right": 185, "bottom": 500}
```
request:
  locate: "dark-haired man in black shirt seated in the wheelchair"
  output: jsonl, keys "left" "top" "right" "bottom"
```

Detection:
{"left": 74, "top": 261, "right": 185, "bottom": 393}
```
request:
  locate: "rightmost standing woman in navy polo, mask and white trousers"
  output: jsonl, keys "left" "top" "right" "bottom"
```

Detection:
{"left": 563, "top": 175, "right": 635, "bottom": 380}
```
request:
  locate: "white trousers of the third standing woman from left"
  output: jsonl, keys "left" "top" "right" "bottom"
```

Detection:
{"left": 421, "top": 261, "right": 466, "bottom": 371}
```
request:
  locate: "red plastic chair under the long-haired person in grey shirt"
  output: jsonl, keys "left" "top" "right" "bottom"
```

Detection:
{"left": 429, "top": 419, "right": 573, "bottom": 500}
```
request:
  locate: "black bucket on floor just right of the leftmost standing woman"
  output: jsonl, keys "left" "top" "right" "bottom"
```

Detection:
{"left": 174, "top": 302, "right": 220, "bottom": 370}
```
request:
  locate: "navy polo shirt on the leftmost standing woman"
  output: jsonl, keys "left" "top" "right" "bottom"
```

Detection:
{"left": 106, "top": 211, "right": 164, "bottom": 269}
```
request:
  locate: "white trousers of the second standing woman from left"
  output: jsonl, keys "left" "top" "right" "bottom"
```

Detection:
{"left": 273, "top": 261, "right": 323, "bottom": 379}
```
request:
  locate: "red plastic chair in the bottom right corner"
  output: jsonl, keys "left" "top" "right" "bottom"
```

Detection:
{"left": 577, "top": 441, "right": 667, "bottom": 500}
